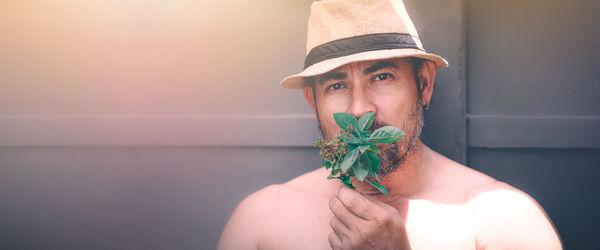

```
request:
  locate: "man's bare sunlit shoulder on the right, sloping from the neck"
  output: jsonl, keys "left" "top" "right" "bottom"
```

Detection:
{"left": 422, "top": 148, "right": 561, "bottom": 249}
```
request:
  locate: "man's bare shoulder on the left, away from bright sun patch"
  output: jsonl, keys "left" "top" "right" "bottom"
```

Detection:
{"left": 218, "top": 169, "right": 336, "bottom": 249}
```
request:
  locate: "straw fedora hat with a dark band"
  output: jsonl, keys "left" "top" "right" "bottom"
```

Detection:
{"left": 281, "top": 0, "right": 448, "bottom": 89}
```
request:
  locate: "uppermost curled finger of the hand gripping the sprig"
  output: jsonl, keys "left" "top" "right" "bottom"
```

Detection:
{"left": 337, "top": 186, "right": 379, "bottom": 220}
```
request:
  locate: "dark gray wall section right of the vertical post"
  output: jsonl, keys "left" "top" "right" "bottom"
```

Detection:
{"left": 466, "top": 0, "right": 600, "bottom": 249}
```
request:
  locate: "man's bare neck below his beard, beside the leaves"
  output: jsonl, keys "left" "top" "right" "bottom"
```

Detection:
{"left": 353, "top": 140, "right": 431, "bottom": 203}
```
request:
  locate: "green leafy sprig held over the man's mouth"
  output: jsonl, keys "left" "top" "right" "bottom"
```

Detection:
{"left": 315, "top": 112, "right": 404, "bottom": 198}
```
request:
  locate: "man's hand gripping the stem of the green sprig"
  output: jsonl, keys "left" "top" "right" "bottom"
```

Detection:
{"left": 329, "top": 186, "right": 410, "bottom": 249}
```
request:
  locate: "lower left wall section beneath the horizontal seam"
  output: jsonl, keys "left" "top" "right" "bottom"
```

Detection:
{"left": 0, "top": 147, "right": 319, "bottom": 249}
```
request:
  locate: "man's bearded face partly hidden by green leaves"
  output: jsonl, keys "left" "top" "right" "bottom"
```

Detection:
{"left": 308, "top": 58, "right": 423, "bottom": 177}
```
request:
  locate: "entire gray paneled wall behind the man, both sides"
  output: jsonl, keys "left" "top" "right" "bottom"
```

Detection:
{"left": 0, "top": 0, "right": 600, "bottom": 249}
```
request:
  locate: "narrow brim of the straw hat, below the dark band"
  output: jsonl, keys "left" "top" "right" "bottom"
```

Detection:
{"left": 280, "top": 49, "right": 448, "bottom": 89}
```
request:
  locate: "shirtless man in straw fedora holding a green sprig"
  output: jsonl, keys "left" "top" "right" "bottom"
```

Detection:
{"left": 219, "top": 0, "right": 561, "bottom": 249}
